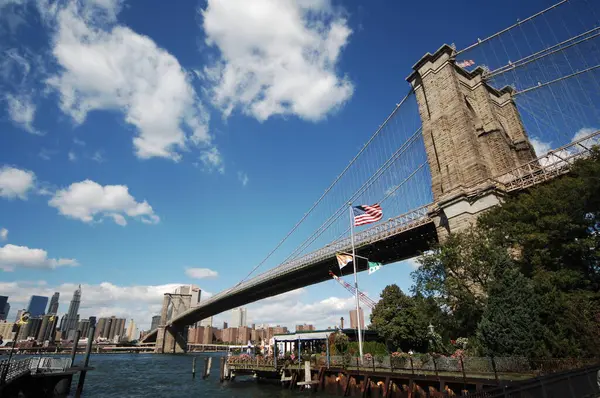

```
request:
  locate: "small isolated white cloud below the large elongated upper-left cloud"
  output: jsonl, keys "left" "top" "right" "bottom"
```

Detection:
{"left": 48, "top": 180, "right": 160, "bottom": 225}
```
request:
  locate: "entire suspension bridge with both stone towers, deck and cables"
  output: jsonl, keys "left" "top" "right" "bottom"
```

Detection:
{"left": 144, "top": 0, "right": 600, "bottom": 352}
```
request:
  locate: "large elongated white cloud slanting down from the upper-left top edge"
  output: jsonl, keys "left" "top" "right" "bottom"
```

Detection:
{"left": 40, "top": 0, "right": 212, "bottom": 160}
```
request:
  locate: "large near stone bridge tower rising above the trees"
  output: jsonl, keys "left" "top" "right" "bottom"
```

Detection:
{"left": 407, "top": 45, "right": 536, "bottom": 238}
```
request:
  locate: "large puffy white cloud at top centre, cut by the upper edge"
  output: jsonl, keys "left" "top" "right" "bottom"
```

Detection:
{"left": 202, "top": 0, "right": 354, "bottom": 121}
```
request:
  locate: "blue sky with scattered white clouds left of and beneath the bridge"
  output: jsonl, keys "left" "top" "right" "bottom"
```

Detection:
{"left": 0, "top": 0, "right": 564, "bottom": 327}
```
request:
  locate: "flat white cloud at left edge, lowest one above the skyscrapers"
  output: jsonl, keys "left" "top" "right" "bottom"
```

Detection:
{"left": 0, "top": 244, "right": 79, "bottom": 271}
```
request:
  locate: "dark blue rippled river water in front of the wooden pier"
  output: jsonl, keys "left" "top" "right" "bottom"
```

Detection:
{"left": 71, "top": 354, "right": 326, "bottom": 398}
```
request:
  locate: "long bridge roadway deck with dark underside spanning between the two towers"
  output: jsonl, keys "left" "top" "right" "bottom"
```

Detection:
{"left": 143, "top": 206, "right": 437, "bottom": 341}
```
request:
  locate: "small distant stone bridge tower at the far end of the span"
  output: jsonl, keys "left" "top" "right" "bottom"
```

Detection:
{"left": 154, "top": 286, "right": 192, "bottom": 354}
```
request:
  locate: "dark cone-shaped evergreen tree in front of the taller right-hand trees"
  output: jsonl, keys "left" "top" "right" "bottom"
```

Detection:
{"left": 477, "top": 267, "right": 543, "bottom": 357}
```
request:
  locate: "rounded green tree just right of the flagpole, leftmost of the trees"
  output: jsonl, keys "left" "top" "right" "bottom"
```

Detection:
{"left": 371, "top": 285, "right": 427, "bottom": 351}
